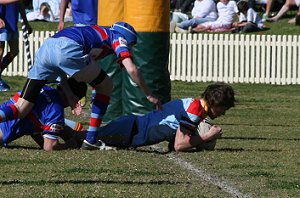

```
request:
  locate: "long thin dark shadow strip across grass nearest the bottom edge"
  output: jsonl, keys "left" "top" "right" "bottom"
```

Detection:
{"left": 0, "top": 179, "right": 190, "bottom": 185}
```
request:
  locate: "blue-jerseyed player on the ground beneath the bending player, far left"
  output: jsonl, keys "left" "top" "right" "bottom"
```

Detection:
{"left": 0, "top": 78, "right": 87, "bottom": 151}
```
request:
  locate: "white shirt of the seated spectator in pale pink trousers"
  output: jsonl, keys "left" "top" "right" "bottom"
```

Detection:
{"left": 217, "top": 1, "right": 239, "bottom": 25}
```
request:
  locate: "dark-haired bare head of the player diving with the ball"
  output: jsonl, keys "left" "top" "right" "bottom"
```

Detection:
{"left": 201, "top": 83, "right": 236, "bottom": 119}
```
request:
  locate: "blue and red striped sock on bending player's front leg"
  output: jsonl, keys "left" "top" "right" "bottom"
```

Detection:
{"left": 86, "top": 93, "right": 110, "bottom": 144}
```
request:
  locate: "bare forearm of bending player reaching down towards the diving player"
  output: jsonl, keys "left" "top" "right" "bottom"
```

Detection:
{"left": 122, "top": 57, "right": 162, "bottom": 109}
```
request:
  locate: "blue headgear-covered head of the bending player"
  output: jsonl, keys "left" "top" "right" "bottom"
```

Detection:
{"left": 111, "top": 22, "right": 137, "bottom": 46}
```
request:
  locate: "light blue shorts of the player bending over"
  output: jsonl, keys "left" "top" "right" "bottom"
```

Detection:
{"left": 28, "top": 37, "right": 91, "bottom": 82}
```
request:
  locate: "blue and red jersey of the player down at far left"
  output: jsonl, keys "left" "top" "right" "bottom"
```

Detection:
{"left": 0, "top": 86, "right": 64, "bottom": 144}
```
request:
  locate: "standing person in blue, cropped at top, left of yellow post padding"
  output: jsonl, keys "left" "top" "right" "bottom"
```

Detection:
{"left": 58, "top": 0, "right": 98, "bottom": 30}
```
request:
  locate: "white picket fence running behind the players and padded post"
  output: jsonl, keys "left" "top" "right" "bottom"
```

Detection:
{"left": 3, "top": 31, "right": 300, "bottom": 84}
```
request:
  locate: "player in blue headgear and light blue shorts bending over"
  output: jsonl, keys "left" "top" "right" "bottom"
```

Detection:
{"left": 0, "top": 22, "right": 161, "bottom": 149}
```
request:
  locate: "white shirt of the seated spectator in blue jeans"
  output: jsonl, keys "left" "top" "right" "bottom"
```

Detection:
{"left": 192, "top": 0, "right": 218, "bottom": 19}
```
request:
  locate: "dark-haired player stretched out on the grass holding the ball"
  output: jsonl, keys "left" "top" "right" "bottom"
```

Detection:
{"left": 69, "top": 83, "right": 236, "bottom": 151}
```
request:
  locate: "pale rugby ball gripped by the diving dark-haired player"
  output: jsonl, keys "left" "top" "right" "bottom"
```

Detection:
{"left": 196, "top": 118, "right": 217, "bottom": 151}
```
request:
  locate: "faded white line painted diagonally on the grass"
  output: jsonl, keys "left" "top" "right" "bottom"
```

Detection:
{"left": 151, "top": 145, "right": 250, "bottom": 198}
